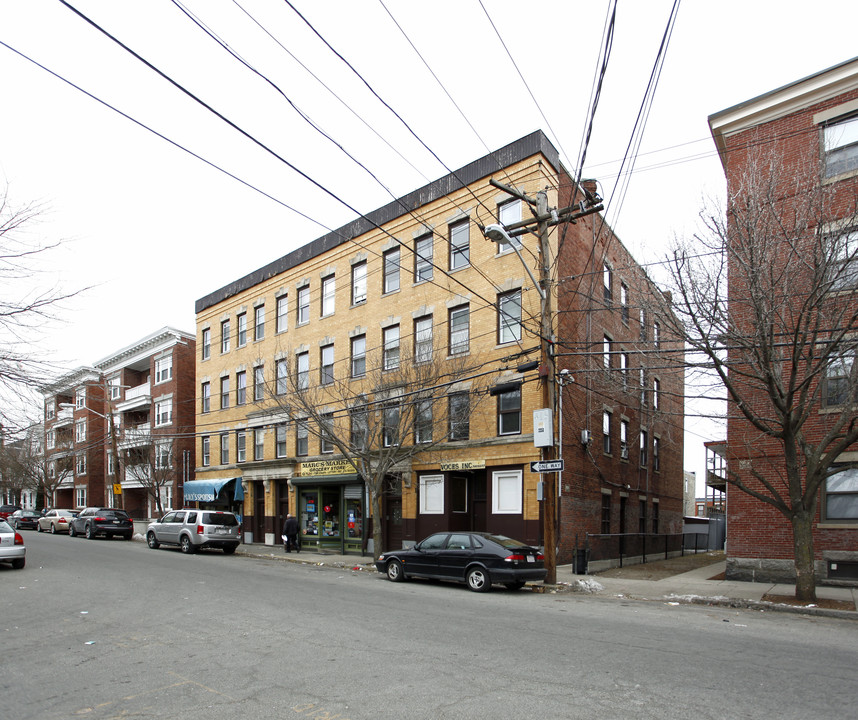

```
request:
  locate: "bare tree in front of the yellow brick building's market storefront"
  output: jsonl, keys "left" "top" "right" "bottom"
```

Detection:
{"left": 272, "top": 334, "right": 498, "bottom": 558}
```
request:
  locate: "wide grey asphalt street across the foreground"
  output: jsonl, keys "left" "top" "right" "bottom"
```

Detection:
{"left": 0, "top": 531, "right": 858, "bottom": 720}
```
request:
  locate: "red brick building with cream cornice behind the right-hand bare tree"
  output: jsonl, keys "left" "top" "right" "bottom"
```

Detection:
{"left": 709, "top": 59, "right": 858, "bottom": 582}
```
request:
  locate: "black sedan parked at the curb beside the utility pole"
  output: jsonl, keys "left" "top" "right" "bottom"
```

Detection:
{"left": 375, "top": 532, "right": 545, "bottom": 592}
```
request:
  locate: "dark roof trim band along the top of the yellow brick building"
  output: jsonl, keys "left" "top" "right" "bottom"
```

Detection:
{"left": 195, "top": 130, "right": 560, "bottom": 313}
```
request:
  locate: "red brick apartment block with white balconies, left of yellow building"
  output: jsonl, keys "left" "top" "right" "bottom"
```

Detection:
{"left": 42, "top": 327, "right": 196, "bottom": 519}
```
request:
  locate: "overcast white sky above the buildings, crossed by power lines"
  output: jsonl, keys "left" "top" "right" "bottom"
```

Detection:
{"left": 0, "top": 0, "right": 858, "bottom": 490}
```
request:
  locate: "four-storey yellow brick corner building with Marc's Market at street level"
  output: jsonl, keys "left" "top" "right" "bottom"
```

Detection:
{"left": 195, "top": 132, "right": 683, "bottom": 562}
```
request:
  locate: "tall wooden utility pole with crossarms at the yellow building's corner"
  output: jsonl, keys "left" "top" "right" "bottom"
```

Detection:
{"left": 481, "top": 180, "right": 603, "bottom": 585}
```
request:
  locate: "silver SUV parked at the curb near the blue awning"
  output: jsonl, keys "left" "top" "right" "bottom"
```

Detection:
{"left": 146, "top": 510, "right": 241, "bottom": 555}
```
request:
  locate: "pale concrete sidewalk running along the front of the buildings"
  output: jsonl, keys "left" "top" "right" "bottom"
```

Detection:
{"left": 237, "top": 544, "right": 858, "bottom": 620}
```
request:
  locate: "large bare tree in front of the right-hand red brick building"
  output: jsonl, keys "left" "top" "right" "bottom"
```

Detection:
{"left": 668, "top": 146, "right": 858, "bottom": 600}
